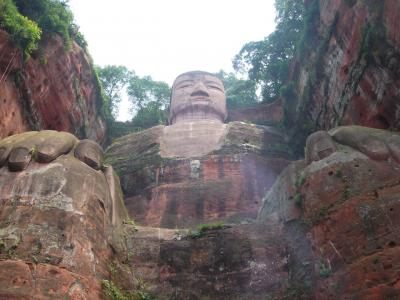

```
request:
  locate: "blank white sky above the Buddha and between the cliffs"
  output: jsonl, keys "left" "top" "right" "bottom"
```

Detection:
{"left": 69, "top": 0, "right": 275, "bottom": 120}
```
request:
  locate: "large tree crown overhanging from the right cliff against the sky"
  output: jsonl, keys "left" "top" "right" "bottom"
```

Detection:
{"left": 233, "top": 0, "right": 306, "bottom": 101}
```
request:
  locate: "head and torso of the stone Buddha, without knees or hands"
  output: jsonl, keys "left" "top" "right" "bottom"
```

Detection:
{"left": 106, "top": 71, "right": 289, "bottom": 228}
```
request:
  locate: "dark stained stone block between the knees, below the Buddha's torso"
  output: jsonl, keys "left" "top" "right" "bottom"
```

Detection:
{"left": 128, "top": 224, "right": 289, "bottom": 299}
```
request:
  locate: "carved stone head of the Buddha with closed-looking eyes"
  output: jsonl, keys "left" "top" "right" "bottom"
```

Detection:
{"left": 169, "top": 71, "right": 226, "bottom": 124}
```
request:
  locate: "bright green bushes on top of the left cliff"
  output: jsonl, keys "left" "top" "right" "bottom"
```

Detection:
{"left": 0, "top": 0, "right": 87, "bottom": 57}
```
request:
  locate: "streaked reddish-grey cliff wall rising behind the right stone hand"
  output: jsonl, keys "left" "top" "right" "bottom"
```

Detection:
{"left": 285, "top": 0, "right": 400, "bottom": 149}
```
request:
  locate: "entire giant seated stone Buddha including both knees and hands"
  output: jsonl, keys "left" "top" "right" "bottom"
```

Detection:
{"left": 0, "top": 72, "right": 400, "bottom": 299}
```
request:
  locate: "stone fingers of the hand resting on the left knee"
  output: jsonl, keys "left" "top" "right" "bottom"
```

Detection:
{"left": 0, "top": 130, "right": 103, "bottom": 171}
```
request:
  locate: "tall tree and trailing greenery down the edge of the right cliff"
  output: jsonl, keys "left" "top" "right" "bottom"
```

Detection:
{"left": 233, "top": 0, "right": 325, "bottom": 157}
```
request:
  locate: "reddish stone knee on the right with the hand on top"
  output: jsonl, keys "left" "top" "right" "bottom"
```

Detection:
{"left": 258, "top": 126, "right": 400, "bottom": 299}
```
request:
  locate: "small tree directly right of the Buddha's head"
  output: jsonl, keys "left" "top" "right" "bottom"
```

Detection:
{"left": 215, "top": 70, "right": 258, "bottom": 108}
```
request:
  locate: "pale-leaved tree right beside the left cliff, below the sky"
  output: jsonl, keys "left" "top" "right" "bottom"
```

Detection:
{"left": 96, "top": 65, "right": 134, "bottom": 119}
